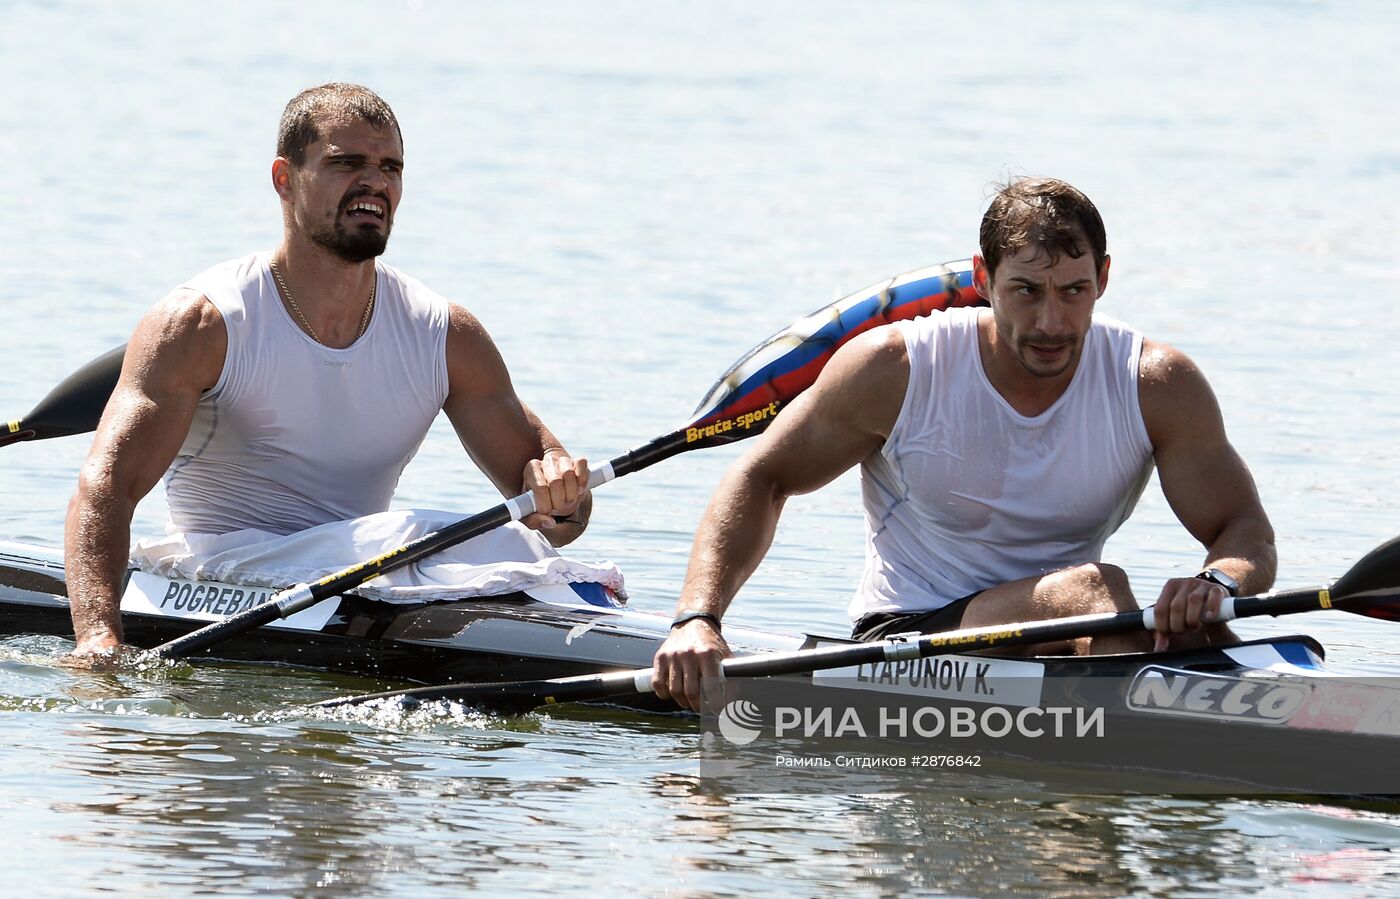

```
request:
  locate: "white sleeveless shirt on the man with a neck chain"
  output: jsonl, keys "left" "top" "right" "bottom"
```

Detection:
{"left": 165, "top": 253, "right": 448, "bottom": 534}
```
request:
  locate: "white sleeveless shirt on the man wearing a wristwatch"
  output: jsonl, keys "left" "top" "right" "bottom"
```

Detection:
{"left": 850, "top": 308, "right": 1152, "bottom": 620}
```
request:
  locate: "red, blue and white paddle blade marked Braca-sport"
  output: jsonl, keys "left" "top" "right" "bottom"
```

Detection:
{"left": 687, "top": 259, "right": 983, "bottom": 445}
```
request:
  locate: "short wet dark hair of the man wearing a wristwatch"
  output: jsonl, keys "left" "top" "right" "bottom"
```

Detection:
{"left": 979, "top": 178, "right": 1109, "bottom": 274}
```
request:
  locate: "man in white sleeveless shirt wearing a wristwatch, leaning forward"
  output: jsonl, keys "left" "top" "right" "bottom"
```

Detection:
{"left": 652, "top": 179, "right": 1275, "bottom": 709}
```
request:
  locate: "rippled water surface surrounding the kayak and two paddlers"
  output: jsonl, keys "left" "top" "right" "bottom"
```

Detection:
{"left": 0, "top": 0, "right": 1400, "bottom": 896}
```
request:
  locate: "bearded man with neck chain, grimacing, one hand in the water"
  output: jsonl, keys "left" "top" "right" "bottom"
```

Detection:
{"left": 64, "top": 84, "right": 591, "bottom": 658}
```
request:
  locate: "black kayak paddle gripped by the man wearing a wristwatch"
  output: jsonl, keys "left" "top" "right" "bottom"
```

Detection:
{"left": 315, "top": 538, "right": 1400, "bottom": 711}
